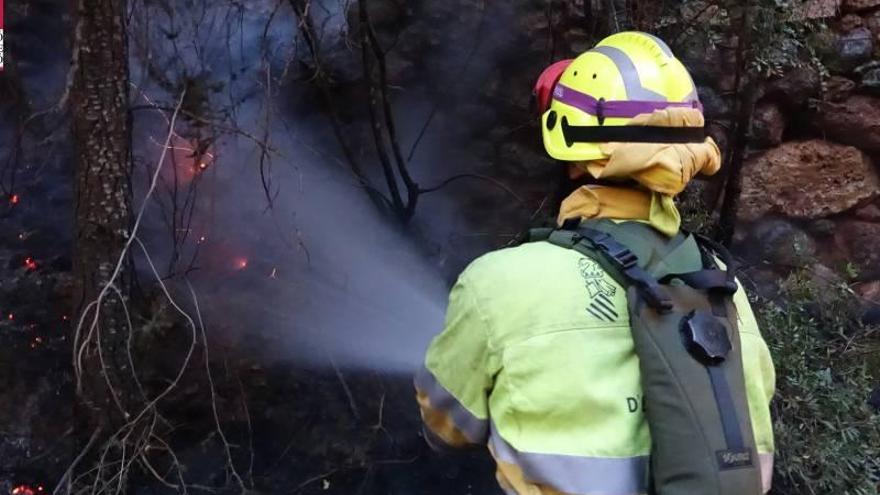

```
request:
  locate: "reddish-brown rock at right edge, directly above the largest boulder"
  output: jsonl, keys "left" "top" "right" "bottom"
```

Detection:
{"left": 818, "top": 95, "right": 880, "bottom": 151}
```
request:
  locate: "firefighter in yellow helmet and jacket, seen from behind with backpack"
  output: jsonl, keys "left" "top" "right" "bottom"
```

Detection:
{"left": 416, "top": 32, "right": 775, "bottom": 495}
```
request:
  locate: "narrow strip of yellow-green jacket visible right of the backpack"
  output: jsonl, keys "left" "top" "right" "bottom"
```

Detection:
{"left": 734, "top": 286, "right": 776, "bottom": 493}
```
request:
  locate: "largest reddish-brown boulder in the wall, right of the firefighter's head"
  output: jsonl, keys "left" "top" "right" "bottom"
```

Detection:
{"left": 740, "top": 140, "right": 880, "bottom": 221}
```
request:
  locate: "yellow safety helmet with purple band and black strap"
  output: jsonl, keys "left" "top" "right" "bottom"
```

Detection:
{"left": 535, "top": 32, "right": 705, "bottom": 162}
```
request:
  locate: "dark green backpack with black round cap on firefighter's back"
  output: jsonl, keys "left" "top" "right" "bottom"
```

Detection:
{"left": 529, "top": 220, "right": 762, "bottom": 495}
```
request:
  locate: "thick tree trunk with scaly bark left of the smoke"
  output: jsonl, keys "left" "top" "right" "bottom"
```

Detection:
{"left": 70, "top": 0, "right": 132, "bottom": 425}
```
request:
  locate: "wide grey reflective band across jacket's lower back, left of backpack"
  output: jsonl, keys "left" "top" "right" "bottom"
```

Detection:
{"left": 489, "top": 424, "right": 649, "bottom": 495}
